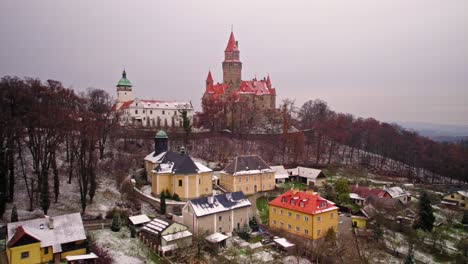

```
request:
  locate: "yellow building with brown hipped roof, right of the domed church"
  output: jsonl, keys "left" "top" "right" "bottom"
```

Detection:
{"left": 219, "top": 155, "right": 275, "bottom": 195}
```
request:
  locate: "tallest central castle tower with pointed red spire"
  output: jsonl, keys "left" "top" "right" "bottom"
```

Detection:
{"left": 223, "top": 31, "right": 242, "bottom": 89}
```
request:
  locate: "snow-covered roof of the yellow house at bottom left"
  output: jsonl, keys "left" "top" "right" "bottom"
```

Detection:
{"left": 7, "top": 213, "right": 86, "bottom": 253}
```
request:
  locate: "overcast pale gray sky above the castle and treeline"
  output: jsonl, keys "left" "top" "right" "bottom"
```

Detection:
{"left": 0, "top": 0, "right": 468, "bottom": 124}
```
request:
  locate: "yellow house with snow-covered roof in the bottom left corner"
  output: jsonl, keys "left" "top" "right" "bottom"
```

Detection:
{"left": 6, "top": 213, "right": 86, "bottom": 264}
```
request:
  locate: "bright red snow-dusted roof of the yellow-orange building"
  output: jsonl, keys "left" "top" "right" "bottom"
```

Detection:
{"left": 268, "top": 191, "right": 338, "bottom": 215}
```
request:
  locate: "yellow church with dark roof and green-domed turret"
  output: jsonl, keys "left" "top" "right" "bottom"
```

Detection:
{"left": 145, "top": 130, "right": 213, "bottom": 200}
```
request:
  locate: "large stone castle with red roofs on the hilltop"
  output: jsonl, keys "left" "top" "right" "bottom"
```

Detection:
{"left": 203, "top": 31, "right": 276, "bottom": 111}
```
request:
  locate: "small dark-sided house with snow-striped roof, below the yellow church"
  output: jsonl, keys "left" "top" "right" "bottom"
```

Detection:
{"left": 138, "top": 218, "right": 192, "bottom": 255}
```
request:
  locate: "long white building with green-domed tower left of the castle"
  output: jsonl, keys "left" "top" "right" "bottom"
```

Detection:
{"left": 113, "top": 70, "right": 194, "bottom": 128}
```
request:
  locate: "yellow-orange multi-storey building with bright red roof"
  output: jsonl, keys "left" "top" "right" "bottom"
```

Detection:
{"left": 268, "top": 190, "right": 338, "bottom": 239}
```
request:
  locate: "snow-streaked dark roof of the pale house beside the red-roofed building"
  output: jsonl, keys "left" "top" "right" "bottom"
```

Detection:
{"left": 189, "top": 192, "right": 252, "bottom": 217}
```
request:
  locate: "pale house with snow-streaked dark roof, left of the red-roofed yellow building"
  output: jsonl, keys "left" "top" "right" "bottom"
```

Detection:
{"left": 182, "top": 192, "right": 252, "bottom": 235}
